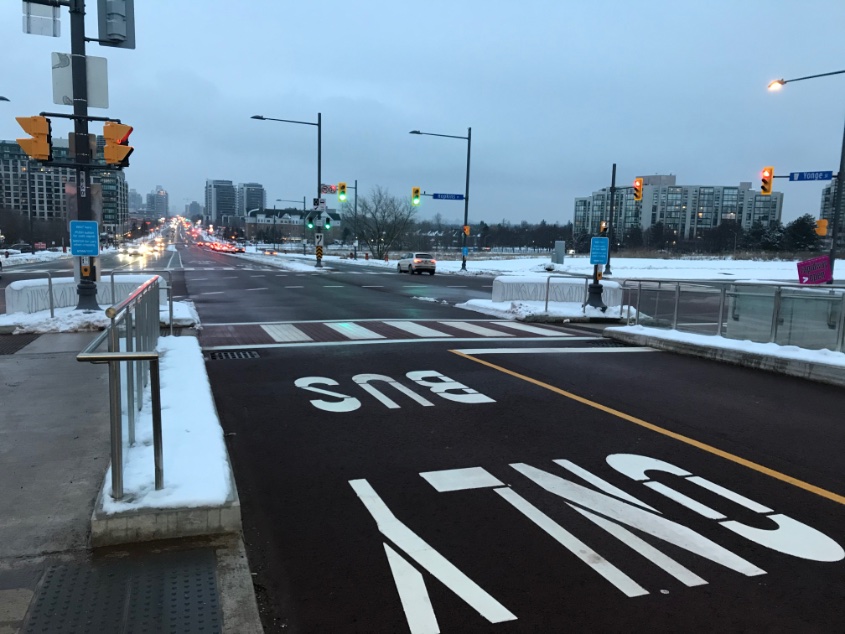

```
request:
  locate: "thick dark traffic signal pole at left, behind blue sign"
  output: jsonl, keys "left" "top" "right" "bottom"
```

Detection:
{"left": 70, "top": 0, "right": 100, "bottom": 310}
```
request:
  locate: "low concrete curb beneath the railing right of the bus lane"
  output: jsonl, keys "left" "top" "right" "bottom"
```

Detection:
{"left": 604, "top": 331, "right": 845, "bottom": 387}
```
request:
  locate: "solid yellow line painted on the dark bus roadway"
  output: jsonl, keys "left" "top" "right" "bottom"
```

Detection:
{"left": 450, "top": 350, "right": 845, "bottom": 505}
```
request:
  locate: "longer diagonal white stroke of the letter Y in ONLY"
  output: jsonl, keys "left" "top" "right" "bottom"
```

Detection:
{"left": 349, "top": 480, "right": 516, "bottom": 631}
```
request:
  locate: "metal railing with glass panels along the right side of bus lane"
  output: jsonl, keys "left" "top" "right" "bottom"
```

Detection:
{"left": 622, "top": 279, "right": 845, "bottom": 352}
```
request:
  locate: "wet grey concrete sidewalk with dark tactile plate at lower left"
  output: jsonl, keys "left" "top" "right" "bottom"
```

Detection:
{"left": 0, "top": 332, "right": 262, "bottom": 634}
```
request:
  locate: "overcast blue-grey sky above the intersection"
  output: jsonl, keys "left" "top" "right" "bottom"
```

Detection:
{"left": 0, "top": 0, "right": 845, "bottom": 223}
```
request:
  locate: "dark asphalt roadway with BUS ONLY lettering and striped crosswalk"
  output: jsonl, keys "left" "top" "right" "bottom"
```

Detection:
{"left": 168, "top": 247, "right": 845, "bottom": 632}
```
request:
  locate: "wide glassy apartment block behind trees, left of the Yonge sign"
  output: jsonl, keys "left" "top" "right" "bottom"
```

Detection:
{"left": 573, "top": 174, "right": 783, "bottom": 240}
